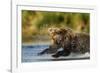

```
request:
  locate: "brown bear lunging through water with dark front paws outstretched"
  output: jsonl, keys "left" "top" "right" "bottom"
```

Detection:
{"left": 39, "top": 28, "right": 90, "bottom": 58}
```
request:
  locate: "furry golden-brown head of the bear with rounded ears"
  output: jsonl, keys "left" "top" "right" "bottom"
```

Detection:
{"left": 48, "top": 28, "right": 73, "bottom": 44}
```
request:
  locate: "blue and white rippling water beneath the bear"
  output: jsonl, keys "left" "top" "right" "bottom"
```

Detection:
{"left": 22, "top": 44, "right": 89, "bottom": 63}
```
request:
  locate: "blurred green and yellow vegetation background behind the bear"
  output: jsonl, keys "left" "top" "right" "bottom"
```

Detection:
{"left": 22, "top": 10, "right": 90, "bottom": 43}
